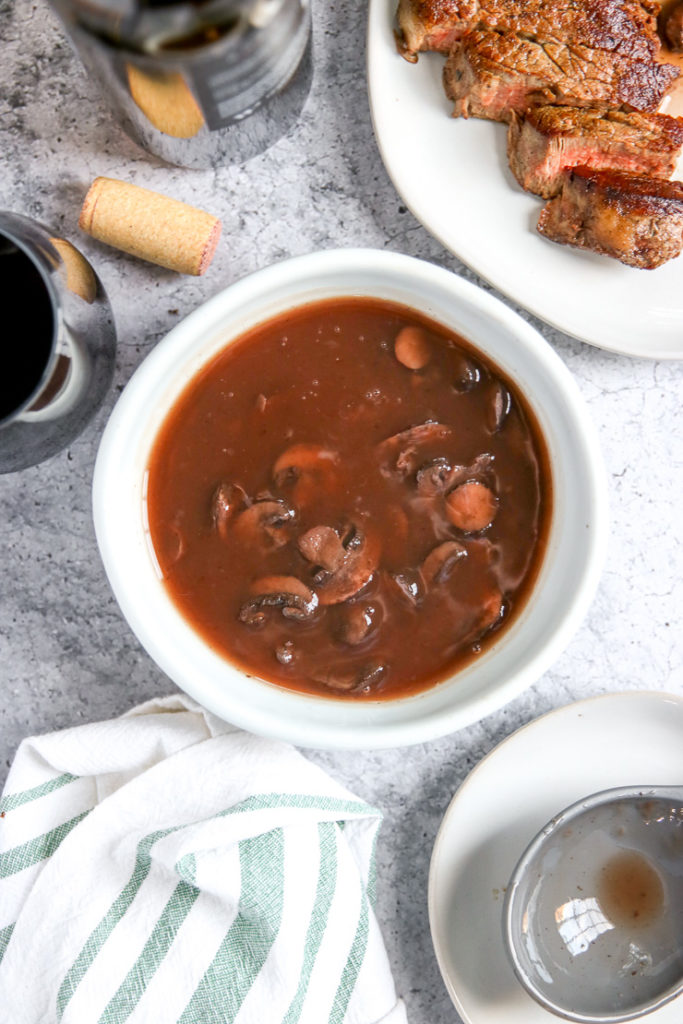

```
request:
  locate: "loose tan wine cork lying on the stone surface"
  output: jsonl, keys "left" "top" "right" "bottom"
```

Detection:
{"left": 78, "top": 178, "right": 221, "bottom": 275}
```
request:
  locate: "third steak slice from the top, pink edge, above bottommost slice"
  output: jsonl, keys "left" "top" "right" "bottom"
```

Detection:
{"left": 508, "top": 106, "right": 683, "bottom": 199}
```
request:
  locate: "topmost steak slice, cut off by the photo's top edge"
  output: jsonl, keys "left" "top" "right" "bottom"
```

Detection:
{"left": 396, "top": 0, "right": 659, "bottom": 59}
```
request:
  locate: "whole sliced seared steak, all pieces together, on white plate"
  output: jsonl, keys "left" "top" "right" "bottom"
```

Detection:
{"left": 396, "top": 0, "right": 683, "bottom": 269}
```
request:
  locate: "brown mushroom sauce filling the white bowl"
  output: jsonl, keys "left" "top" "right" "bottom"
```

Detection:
{"left": 146, "top": 298, "right": 552, "bottom": 699}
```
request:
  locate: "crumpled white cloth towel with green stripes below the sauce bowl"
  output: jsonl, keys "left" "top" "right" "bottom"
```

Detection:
{"left": 0, "top": 695, "right": 405, "bottom": 1024}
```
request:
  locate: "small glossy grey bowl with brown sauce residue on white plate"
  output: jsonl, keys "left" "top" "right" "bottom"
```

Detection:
{"left": 503, "top": 786, "right": 683, "bottom": 1024}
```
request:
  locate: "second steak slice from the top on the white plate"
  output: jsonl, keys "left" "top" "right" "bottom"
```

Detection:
{"left": 443, "top": 30, "right": 680, "bottom": 121}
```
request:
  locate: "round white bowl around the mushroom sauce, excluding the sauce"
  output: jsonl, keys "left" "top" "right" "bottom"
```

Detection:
{"left": 93, "top": 249, "right": 607, "bottom": 749}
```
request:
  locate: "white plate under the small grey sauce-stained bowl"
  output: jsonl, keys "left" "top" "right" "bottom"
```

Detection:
{"left": 429, "top": 692, "right": 683, "bottom": 1024}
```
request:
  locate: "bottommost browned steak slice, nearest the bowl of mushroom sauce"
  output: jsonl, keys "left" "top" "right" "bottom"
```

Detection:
{"left": 538, "top": 167, "right": 683, "bottom": 270}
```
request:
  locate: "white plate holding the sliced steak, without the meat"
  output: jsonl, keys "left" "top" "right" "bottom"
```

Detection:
{"left": 368, "top": 0, "right": 683, "bottom": 359}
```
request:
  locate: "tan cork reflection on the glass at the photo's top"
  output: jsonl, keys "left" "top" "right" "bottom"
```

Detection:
{"left": 126, "top": 65, "right": 204, "bottom": 138}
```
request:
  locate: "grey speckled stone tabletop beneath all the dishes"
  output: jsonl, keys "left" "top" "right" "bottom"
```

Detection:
{"left": 0, "top": 0, "right": 683, "bottom": 1024}
